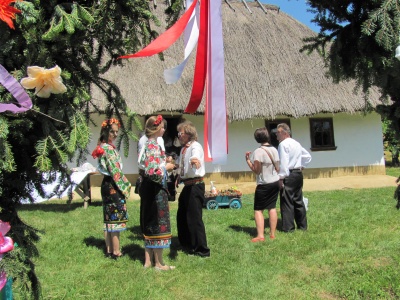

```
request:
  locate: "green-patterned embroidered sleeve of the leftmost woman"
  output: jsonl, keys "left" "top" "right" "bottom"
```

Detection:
{"left": 100, "top": 145, "right": 131, "bottom": 198}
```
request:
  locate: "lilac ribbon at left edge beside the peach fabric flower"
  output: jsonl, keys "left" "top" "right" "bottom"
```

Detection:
{"left": 0, "top": 65, "right": 32, "bottom": 114}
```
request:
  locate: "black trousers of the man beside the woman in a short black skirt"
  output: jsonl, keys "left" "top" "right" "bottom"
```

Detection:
{"left": 280, "top": 171, "right": 307, "bottom": 232}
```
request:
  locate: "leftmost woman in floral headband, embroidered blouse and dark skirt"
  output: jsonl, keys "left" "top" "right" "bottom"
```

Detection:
{"left": 92, "top": 119, "right": 131, "bottom": 259}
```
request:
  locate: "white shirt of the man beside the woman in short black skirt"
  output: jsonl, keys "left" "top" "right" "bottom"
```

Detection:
{"left": 278, "top": 138, "right": 311, "bottom": 179}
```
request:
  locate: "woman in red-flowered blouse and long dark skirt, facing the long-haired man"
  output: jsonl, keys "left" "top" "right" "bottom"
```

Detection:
{"left": 139, "top": 115, "right": 175, "bottom": 271}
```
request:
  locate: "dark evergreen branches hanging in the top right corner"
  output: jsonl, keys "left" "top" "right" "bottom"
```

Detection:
{"left": 303, "top": 0, "right": 400, "bottom": 151}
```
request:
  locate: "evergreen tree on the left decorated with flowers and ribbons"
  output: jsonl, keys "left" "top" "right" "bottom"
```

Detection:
{"left": 0, "top": 0, "right": 182, "bottom": 299}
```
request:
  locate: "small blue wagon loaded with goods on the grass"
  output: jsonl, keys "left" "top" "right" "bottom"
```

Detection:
{"left": 203, "top": 189, "right": 242, "bottom": 210}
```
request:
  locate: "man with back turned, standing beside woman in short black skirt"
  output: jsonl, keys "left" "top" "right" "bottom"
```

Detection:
{"left": 276, "top": 123, "right": 311, "bottom": 232}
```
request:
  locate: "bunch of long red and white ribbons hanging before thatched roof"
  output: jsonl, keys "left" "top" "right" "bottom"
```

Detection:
{"left": 119, "top": 0, "right": 228, "bottom": 164}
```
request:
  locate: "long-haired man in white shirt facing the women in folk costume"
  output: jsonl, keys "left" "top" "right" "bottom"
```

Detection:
{"left": 176, "top": 121, "right": 210, "bottom": 257}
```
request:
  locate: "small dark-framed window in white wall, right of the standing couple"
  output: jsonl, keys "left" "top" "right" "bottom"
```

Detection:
{"left": 309, "top": 118, "right": 337, "bottom": 151}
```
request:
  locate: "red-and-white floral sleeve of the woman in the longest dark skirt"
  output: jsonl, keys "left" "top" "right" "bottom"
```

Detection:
{"left": 144, "top": 140, "right": 165, "bottom": 183}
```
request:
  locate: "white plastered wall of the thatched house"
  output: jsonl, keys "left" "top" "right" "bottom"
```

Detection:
{"left": 71, "top": 113, "right": 384, "bottom": 174}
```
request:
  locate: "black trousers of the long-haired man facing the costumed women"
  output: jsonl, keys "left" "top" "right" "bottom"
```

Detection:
{"left": 176, "top": 182, "right": 210, "bottom": 256}
